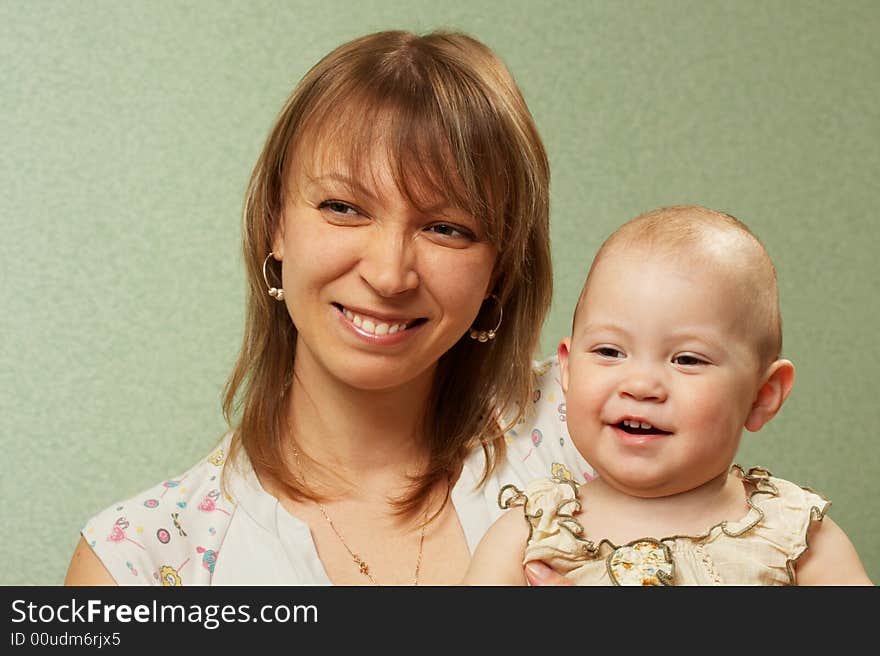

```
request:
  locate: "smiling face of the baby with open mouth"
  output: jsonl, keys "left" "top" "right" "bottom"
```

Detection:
{"left": 559, "top": 246, "right": 763, "bottom": 497}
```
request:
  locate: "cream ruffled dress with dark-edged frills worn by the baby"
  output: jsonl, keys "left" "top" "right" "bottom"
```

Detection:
{"left": 506, "top": 465, "right": 831, "bottom": 585}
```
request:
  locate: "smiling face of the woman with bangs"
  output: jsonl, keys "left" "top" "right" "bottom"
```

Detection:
{"left": 273, "top": 135, "right": 496, "bottom": 390}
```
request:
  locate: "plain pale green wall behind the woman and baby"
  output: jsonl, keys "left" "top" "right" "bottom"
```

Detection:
{"left": 0, "top": 0, "right": 880, "bottom": 584}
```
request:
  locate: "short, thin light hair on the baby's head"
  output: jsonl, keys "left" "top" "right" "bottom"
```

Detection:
{"left": 574, "top": 205, "right": 782, "bottom": 366}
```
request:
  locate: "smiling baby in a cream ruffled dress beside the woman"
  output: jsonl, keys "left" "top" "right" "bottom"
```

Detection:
{"left": 465, "top": 206, "right": 871, "bottom": 585}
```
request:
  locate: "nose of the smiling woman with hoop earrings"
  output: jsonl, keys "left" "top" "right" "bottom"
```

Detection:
{"left": 360, "top": 226, "right": 419, "bottom": 297}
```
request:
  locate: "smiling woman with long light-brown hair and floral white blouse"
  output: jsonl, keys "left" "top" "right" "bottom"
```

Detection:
{"left": 66, "top": 32, "right": 586, "bottom": 585}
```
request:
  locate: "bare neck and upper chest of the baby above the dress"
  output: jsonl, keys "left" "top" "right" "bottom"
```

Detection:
{"left": 577, "top": 473, "right": 748, "bottom": 546}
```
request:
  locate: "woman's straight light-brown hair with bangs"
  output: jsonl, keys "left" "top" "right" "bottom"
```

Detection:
{"left": 223, "top": 31, "right": 552, "bottom": 514}
